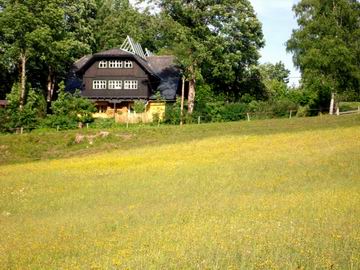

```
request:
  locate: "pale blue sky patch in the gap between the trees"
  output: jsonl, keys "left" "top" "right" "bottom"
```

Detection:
{"left": 250, "top": 0, "right": 300, "bottom": 85}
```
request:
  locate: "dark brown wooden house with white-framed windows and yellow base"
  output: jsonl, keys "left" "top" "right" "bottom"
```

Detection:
{"left": 67, "top": 37, "right": 181, "bottom": 122}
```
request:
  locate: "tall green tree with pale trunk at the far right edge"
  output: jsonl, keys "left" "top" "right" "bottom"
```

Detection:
{"left": 287, "top": 0, "right": 360, "bottom": 106}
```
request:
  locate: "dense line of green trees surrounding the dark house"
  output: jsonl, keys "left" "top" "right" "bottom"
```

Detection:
{"left": 0, "top": 0, "right": 360, "bottom": 131}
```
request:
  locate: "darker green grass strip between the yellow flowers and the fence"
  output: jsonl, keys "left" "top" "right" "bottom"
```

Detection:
{"left": 0, "top": 115, "right": 360, "bottom": 165}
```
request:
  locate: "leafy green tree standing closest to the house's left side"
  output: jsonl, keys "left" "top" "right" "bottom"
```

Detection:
{"left": 36, "top": 0, "right": 96, "bottom": 102}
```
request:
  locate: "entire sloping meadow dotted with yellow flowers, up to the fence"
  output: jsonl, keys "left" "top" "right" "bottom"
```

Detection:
{"left": 0, "top": 115, "right": 360, "bottom": 269}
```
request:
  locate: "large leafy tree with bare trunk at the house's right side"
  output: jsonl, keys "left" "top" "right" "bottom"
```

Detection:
{"left": 153, "top": 0, "right": 264, "bottom": 113}
